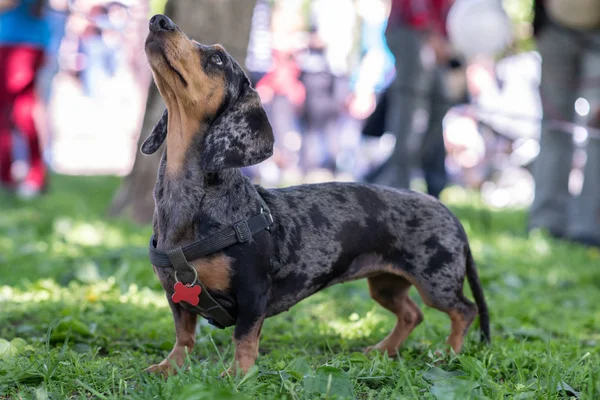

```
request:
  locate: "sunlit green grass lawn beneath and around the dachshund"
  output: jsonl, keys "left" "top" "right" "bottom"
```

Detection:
{"left": 0, "top": 176, "right": 600, "bottom": 399}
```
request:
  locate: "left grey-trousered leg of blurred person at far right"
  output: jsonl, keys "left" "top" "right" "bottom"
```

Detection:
{"left": 529, "top": 25, "right": 580, "bottom": 236}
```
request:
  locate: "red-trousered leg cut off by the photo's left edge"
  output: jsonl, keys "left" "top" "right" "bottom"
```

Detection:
{"left": 0, "top": 46, "right": 14, "bottom": 186}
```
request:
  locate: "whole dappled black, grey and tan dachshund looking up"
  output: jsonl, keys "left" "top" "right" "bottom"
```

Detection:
{"left": 141, "top": 14, "right": 489, "bottom": 374}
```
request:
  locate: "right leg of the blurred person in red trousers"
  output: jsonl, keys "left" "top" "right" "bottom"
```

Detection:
{"left": 12, "top": 47, "right": 46, "bottom": 191}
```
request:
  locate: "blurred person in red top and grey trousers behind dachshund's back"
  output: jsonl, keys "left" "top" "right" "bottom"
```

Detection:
{"left": 366, "top": 0, "right": 453, "bottom": 197}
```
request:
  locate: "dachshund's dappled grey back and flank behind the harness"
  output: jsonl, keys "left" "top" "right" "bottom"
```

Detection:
{"left": 261, "top": 183, "right": 468, "bottom": 308}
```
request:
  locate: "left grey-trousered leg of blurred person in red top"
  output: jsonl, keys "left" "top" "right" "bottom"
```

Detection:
{"left": 369, "top": 27, "right": 424, "bottom": 188}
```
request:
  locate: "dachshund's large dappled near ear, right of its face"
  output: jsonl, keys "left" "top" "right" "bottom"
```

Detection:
{"left": 200, "top": 83, "right": 275, "bottom": 171}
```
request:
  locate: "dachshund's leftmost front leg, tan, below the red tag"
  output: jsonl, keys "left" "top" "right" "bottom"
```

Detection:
{"left": 146, "top": 305, "right": 198, "bottom": 376}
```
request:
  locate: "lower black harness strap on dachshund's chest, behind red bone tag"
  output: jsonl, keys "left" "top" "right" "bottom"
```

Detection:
{"left": 167, "top": 247, "right": 235, "bottom": 328}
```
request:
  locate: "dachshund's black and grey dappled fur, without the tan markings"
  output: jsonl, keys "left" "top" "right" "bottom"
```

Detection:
{"left": 142, "top": 18, "right": 489, "bottom": 362}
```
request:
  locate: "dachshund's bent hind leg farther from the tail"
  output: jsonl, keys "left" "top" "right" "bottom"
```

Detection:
{"left": 367, "top": 273, "right": 423, "bottom": 356}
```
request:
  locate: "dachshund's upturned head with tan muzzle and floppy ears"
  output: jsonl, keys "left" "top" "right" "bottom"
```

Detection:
{"left": 141, "top": 14, "right": 274, "bottom": 171}
